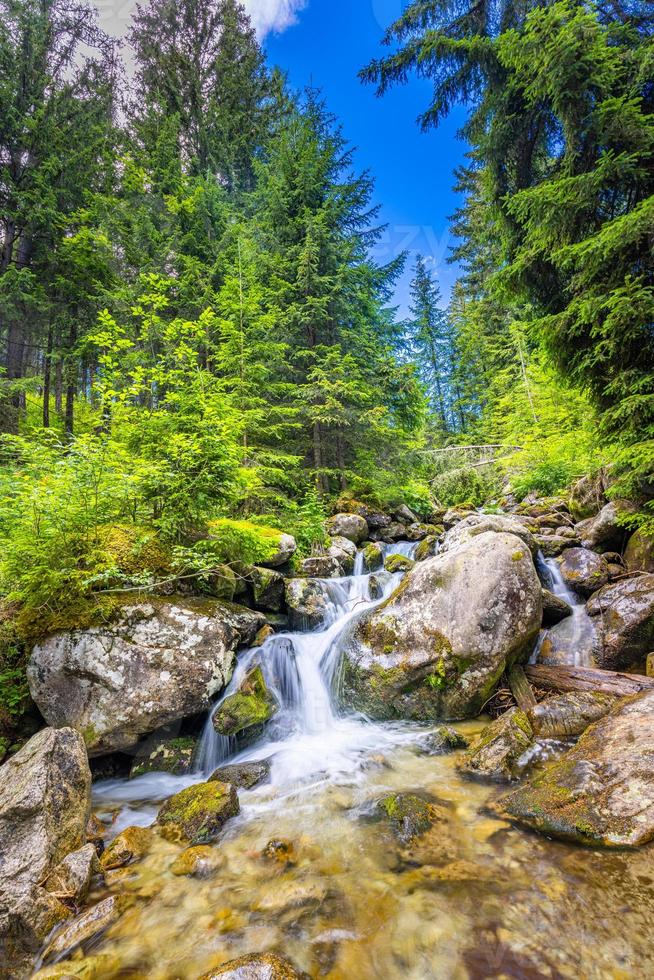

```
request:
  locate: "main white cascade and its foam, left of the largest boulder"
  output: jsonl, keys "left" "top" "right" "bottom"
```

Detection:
{"left": 94, "top": 541, "right": 426, "bottom": 832}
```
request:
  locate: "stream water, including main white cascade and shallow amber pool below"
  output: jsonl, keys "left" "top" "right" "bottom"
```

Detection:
{"left": 59, "top": 544, "right": 654, "bottom": 980}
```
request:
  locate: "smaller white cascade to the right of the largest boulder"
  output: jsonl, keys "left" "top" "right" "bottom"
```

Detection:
{"left": 532, "top": 555, "right": 595, "bottom": 667}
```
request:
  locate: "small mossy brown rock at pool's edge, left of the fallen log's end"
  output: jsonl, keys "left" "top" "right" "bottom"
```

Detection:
{"left": 457, "top": 708, "right": 534, "bottom": 783}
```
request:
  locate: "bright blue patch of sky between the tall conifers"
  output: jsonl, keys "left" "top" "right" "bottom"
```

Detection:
{"left": 264, "top": 0, "right": 465, "bottom": 315}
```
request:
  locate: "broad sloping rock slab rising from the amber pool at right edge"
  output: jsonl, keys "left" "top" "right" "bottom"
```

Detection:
{"left": 501, "top": 691, "right": 654, "bottom": 847}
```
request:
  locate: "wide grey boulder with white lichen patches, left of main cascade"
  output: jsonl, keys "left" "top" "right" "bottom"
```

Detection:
{"left": 27, "top": 599, "right": 265, "bottom": 756}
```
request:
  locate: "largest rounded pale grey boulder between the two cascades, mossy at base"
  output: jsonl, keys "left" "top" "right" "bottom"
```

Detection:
{"left": 337, "top": 532, "right": 542, "bottom": 720}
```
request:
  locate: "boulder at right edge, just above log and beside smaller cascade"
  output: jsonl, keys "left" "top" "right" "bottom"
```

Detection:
{"left": 586, "top": 575, "right": 654, "bottom": 670}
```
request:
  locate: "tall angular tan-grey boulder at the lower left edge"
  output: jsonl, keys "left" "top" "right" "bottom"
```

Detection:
{"left": 0, "top": 728, "right": 91, "bottom": 976}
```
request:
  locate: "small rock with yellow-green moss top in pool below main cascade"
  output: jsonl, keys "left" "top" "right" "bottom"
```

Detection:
{"left": 157, "top": 781, "right": 240, "bottom": 845}
